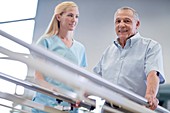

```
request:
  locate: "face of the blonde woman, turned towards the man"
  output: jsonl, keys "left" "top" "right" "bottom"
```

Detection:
{"left": 58, "top": 7, "right": 79, "bottom": 31}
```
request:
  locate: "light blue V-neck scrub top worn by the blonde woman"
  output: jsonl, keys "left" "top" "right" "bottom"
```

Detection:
{"left": 32, "top": 35, "right": 87, "bottom": 113}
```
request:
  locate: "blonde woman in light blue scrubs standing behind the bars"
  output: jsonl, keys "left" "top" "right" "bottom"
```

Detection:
{"left": 32, "top": 1, "right": 87, "bottom": 113}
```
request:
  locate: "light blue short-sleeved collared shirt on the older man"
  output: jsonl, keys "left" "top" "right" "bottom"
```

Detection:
{"left": 93, "top": 33, "right": 165, "bottom": 97}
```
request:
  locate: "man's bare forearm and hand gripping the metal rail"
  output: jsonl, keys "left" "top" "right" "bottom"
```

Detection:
{"left": 145, "top": 71, "right": 159, "bottom": 110}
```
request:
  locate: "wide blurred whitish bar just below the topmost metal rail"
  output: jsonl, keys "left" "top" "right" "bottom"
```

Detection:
{"left": 0, "top": 43, "right": 155, "bottom": 113}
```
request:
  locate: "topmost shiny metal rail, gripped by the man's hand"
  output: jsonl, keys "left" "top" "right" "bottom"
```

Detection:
{"left": 0, "top": 30, "right": 170, "bottom": 113}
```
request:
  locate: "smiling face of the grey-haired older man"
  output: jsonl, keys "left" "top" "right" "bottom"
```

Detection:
{"left": 115, "top": 10, "right": 139, "bottom": 39}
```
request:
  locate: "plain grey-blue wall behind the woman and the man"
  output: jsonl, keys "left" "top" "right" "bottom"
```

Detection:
{"left": 33, "top": 0, "right": 170, "bottom": 83}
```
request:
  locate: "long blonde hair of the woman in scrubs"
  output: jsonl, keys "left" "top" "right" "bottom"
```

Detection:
{"left": 43, "top": 1, "right": 78, "bottom": 37}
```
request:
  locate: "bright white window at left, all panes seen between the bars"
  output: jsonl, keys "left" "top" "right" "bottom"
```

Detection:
{"left": 0, "top": 0, "right": 38, "bottom": 111}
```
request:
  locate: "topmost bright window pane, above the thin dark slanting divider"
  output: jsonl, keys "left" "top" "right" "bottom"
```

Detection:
{"left": 0, "top": 0, "right": 38, "bottom": 22}
